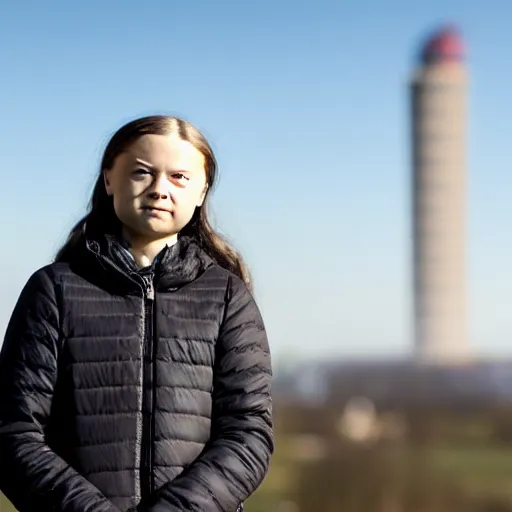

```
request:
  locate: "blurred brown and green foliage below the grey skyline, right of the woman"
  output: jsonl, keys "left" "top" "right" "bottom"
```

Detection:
{"left": 246, "top": 404, "right": 512, "bottom": 512}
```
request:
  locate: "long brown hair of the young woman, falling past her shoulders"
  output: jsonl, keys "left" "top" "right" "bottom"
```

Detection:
{"left": 55, "top": 115, "right": 251, "bottom": 286}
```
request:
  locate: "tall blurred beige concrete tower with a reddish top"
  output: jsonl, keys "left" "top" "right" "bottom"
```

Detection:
{"left": 411, "top": 27, "right": 469, "bottom": 363}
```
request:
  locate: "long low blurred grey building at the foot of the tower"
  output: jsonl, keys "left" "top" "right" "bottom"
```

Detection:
{"left": 324, "top": 360, "right": 512, "bottom": 409}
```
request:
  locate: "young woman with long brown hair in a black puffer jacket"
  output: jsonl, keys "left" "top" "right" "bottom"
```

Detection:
{"left": 0, "top": 116, "right": 273, "bottom": 512}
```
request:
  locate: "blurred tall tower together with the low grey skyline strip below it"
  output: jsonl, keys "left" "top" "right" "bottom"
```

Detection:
{"left": 275, "top": 26, "right": 512, "bottom": 408}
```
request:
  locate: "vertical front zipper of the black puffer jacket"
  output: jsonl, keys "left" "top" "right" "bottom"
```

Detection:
{"left": 135, "top": 274, "right": 155, "bottom": 501}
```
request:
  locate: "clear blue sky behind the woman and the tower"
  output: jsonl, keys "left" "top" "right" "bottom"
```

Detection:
{"left": 0, "top": 0, "right": 512, "bottom": 368}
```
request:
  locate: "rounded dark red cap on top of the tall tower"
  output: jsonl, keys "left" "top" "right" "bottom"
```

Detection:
{"left": 420, "top": 25, "right": 464, "bottom": 65}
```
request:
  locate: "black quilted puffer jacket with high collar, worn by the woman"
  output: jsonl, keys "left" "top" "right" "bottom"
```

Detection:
{"left": 0, "top": 238, "right": 273, "bottom": 512}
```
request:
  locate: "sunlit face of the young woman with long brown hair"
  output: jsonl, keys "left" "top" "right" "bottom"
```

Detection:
{"left": 104, "top": 134, "right": 207, "bottom": 242}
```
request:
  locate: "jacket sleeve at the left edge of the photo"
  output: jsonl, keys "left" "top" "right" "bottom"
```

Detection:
{"left": 0, "top": 269, "right": 121, "bottom": 512}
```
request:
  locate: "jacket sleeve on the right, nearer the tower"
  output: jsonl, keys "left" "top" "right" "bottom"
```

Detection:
{"left": 149, "top": 278, "right": 274, "bottom": 512}
